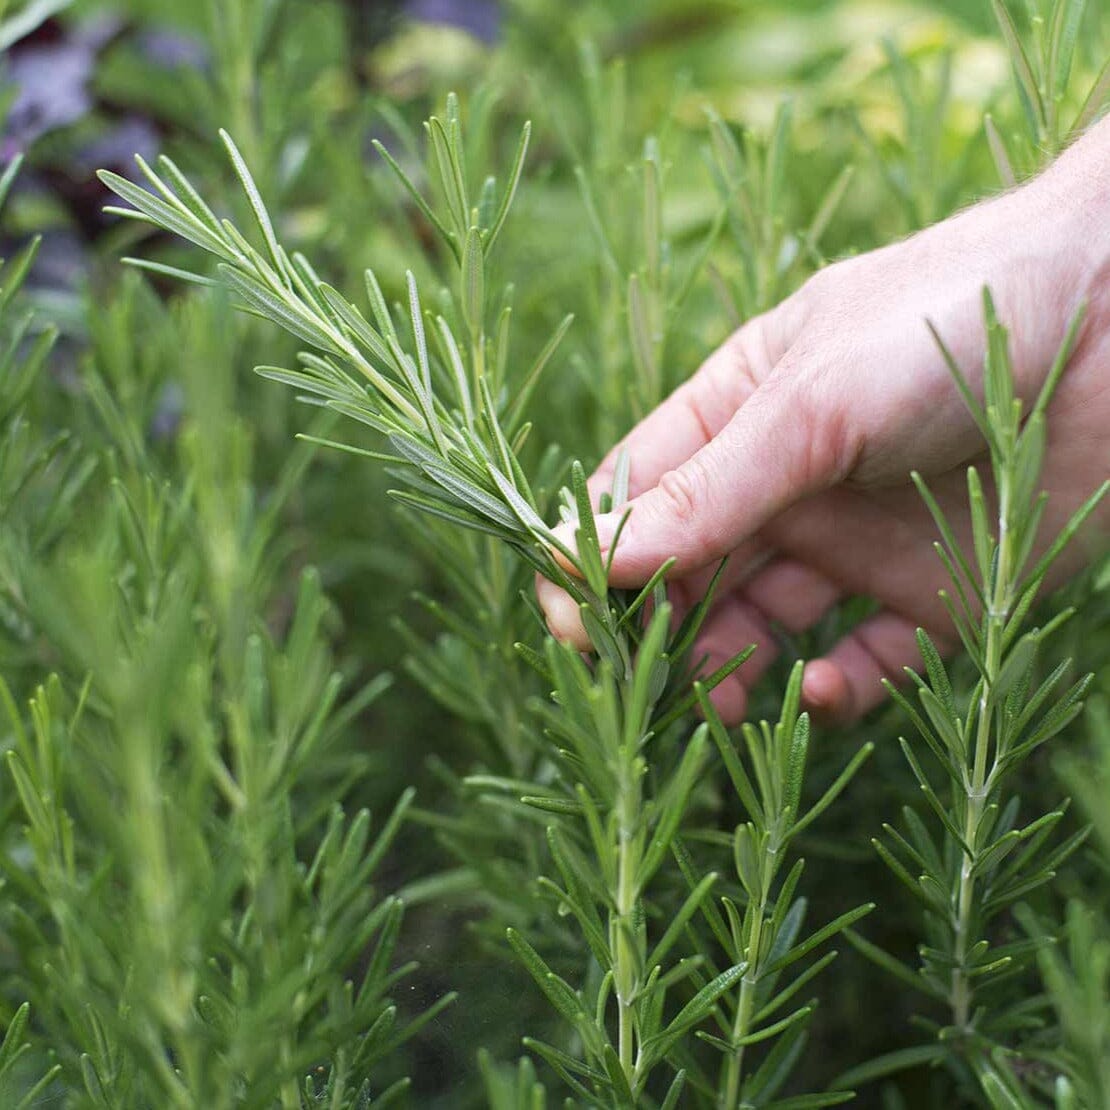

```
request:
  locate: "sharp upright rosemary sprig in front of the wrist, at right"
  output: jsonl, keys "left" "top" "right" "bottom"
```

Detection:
{"left": 842, "top": 293, "right": 1110, "bottom": 1104}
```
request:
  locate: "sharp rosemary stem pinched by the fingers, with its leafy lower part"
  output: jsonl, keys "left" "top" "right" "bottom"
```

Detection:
{"left": 97, "top": 101, "right": 743, "bottom": 1104}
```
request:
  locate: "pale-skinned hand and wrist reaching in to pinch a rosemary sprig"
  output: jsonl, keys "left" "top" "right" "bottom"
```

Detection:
{"left": 536, "top": 110, "right": 1110, "bottom": 723}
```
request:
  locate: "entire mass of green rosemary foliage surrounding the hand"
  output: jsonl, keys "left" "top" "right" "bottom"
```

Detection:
{"left": 0, "top": 0, "right": 1110, "bottom": 1110}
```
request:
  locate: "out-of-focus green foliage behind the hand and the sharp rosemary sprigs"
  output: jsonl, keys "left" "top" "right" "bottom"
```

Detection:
{"left": 0, "top": 0, "right": 1110, "bottom": 1108}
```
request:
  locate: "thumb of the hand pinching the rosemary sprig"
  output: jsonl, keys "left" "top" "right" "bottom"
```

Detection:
{"left": 597, "top": 367, "right": 857, "bottom": 587}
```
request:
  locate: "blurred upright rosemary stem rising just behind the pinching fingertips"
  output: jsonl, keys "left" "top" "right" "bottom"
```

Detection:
{"left": 542, "top": 40, "right": 725, "bottom": 441}
